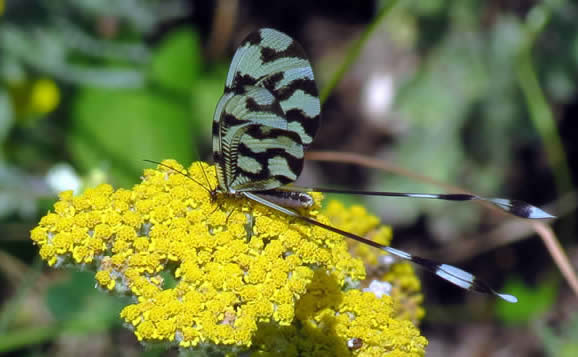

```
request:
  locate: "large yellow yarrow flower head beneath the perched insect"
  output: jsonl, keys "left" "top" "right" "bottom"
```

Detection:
{"left": 31, "top": 160, "right": 427, "bottom": 356}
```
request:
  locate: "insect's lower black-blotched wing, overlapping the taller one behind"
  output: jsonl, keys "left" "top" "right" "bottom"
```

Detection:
{"left": 213, "top": 86, "right": 303, "bottom": 192}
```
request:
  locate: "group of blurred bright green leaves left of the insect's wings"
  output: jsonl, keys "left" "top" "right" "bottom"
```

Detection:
{"left": 69, "top": 30, "right": 224, "bottom": 186}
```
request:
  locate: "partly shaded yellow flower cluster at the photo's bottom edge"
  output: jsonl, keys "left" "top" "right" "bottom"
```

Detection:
{"left": 254, "top": 271, "right": 427, "bottom": 357}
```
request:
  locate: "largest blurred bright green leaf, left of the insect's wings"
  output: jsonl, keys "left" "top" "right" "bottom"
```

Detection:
{"left": 69, "top": 89, "right": 193, "bottom": 185}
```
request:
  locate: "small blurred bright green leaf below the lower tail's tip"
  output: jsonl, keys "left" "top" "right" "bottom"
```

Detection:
{"left": 496, "top": 279, "right": 558, "bottom": 325}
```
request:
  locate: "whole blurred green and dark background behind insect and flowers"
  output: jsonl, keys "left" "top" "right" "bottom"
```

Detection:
{"left": 0, "top": 0, "right": 578, "bottom": 356}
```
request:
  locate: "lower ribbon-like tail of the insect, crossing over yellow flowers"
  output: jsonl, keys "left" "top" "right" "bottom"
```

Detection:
{"left": 242, "top": 192, "right": 518, "bottom": 303}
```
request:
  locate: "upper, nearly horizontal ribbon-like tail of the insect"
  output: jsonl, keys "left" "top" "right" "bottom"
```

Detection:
{"left": 279, "top": 186, "right": 556, "bottom": 219}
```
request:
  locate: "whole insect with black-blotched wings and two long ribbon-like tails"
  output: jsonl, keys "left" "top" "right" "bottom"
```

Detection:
{"left": 147, "top": 29, "right": 554, "bottom": 302}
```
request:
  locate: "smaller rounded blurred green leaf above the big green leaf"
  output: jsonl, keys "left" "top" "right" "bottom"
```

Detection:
{"left": 150, "top": 30, "right": 201, "bottom": 93}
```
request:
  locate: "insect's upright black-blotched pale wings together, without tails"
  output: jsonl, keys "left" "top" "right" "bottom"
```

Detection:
{"left": 213, "top": 29, "right": 321, "bottom": 193}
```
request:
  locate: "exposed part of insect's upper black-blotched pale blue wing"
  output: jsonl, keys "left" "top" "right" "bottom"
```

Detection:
{"left": 225, "top": 29, "right": 321, "bottom": 146}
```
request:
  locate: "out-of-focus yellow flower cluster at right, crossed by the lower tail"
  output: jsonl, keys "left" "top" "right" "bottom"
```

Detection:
{"left": 323, "top": 201, "right": 425, "bottom": 323}
